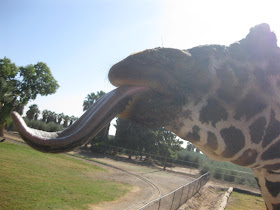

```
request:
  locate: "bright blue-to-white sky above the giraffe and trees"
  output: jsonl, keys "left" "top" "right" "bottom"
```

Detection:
{"left": 0, "top": 0, "right": 280, "bottom": 134}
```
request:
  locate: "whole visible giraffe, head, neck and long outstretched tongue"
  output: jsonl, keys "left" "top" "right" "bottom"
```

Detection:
{"left": 12, "top": 24, "right": 280, "bottom": 210}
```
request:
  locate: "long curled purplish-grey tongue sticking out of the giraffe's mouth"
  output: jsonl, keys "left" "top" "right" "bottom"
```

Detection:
{"left": 11, "top": 86, "right": 148, "bottom": 153}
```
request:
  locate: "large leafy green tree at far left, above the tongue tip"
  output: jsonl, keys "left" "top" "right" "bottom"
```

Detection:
{"left": 0, "top": 57, "right": 59, "bottom": 136}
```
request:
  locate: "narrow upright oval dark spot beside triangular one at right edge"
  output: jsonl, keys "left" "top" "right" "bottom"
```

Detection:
{"left": 249, "top": 117, "right": 266, "bottom": 144}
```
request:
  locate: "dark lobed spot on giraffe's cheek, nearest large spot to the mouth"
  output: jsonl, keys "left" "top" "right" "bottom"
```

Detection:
{"left": 199, "top": 98, "right": 228, "bottom": 127}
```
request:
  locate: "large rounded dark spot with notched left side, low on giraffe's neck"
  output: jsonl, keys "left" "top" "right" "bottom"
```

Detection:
{"left": 220, "top": 126, "right": 245, "bottom": 158}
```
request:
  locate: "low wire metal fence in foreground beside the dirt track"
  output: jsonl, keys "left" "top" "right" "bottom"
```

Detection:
{"left": 139, "top": 172, "right": 210, "bottom": 210}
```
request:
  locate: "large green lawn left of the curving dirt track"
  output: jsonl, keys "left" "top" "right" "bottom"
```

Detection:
{"left": 0, "top": 142, "right": 130, "bottom": 209}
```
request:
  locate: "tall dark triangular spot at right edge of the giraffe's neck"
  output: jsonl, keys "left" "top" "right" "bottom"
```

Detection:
{"left": 262, "top": 110, "right": 280, "bottom": 147}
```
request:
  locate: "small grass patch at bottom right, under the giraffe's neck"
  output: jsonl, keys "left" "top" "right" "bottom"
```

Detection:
{"left": 225, "top": 192, "right": 266, "bottom": 210}
